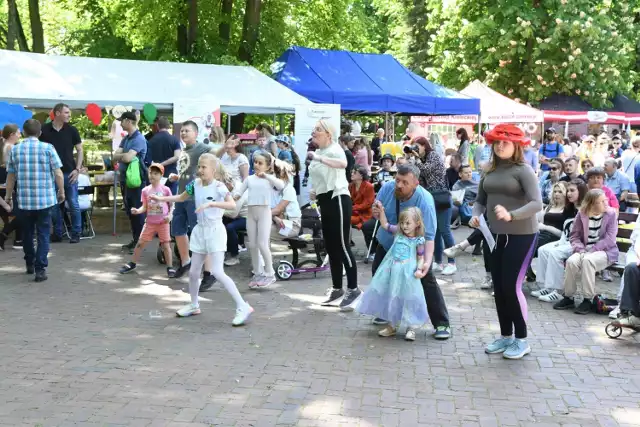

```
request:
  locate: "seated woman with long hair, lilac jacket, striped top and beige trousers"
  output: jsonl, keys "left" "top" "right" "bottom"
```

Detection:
{"left": 553, "top": 189, "right": 618, "bottom": 314}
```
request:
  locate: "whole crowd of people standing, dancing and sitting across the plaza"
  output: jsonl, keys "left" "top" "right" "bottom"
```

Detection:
{"left": 0, "top": 104, "right": 640, "bottom": 359}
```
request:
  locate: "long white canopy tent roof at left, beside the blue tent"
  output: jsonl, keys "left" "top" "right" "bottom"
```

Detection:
{"left": 0, "top": 50, "right": 311, "bottom": 115}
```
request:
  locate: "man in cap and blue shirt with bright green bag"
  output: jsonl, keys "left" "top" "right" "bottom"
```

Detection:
{"left": 113, "top": 111, "right": 147, "bottom": 252}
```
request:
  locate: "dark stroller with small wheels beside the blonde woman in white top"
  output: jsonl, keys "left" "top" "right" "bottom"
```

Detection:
{"left": 276, "top": 202, "right": 329, "bottom": 280}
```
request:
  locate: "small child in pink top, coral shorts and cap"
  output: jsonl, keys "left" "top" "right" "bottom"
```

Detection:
{"left": 120, "top": 163, "right": 176, "bottom": 278}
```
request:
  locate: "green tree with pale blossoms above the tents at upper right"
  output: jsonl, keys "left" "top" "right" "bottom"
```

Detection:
{"left": 429, "top": 0, "right": 638, "bottom": 107}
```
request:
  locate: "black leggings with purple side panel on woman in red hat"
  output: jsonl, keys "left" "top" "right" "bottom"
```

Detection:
{"left": 491, "top": 233, "right": 538, "bottom": 338}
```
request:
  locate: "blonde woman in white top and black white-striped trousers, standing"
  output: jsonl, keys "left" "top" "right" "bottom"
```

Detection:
{"left": 307, "top": 120, "right": 362, "bottom": 311}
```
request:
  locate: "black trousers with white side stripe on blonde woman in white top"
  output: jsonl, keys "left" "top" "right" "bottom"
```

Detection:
{"left": 318, "top": 192, "right": 358, "bottom": 289}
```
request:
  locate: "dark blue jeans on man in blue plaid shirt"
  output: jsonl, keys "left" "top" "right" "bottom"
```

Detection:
{"left": 20, "top": 206, "right": 52, "bottom": 271}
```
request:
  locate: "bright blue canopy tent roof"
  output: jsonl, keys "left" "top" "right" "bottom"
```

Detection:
{"left": 272, "top": 46, "right": 480, "bottom": 115}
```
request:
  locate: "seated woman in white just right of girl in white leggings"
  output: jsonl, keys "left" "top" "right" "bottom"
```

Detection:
{"left": 271, "top": 160, "right": 302, "bottom": 240}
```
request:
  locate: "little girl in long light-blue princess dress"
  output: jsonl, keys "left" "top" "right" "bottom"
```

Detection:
{"left": 356, "top": 206, "right": 429, "bottom": 341}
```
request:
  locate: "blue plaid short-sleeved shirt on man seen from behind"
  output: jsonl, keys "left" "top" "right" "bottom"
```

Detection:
{"left": 7, "top": 138, "right": 62, "bottom": 211}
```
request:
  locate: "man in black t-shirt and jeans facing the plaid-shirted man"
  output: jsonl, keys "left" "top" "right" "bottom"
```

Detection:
{"left": 40, "top": 103, "right": 83, "bottom": 243}
